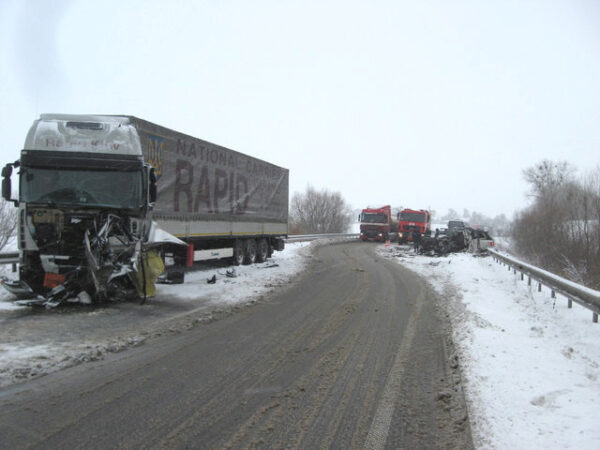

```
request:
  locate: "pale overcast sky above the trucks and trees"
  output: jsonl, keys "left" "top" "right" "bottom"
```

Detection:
{"left": 0, "top": 0, "right": 600, "bottom": 218}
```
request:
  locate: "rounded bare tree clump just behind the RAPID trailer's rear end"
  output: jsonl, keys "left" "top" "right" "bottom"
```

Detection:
{"left": 290, "top": 186, "right": 352, "bottom": 234}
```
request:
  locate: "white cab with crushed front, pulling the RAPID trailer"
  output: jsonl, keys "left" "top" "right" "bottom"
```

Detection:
{"left": 2, "top": 116, "right": 180, "bottom": 306}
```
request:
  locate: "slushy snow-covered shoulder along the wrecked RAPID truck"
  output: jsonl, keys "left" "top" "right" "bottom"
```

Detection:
{"left": 0, "top": 242, "right": 322, "bottom": 387}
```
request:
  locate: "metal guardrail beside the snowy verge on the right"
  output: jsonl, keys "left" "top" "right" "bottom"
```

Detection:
{"left": 488, "top": 249, "right": 600, "bottom": 323}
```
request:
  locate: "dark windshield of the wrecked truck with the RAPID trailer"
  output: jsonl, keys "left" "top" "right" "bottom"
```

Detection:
{"left": 19, "top": 167, "right": 143, "bottom": 209}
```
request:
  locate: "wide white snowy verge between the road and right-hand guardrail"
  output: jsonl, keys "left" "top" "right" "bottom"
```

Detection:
{"left": 381, "top": 247, "right": 600, "bottom": 449}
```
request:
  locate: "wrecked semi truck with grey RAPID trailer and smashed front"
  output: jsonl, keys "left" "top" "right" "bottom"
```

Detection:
{"left": 2, "top": 114, "right": 289, "bottom": 304}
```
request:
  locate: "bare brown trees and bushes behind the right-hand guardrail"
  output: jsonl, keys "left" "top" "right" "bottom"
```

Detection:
{"left": 511, "top": 160, "right": 600, "bottom": 289}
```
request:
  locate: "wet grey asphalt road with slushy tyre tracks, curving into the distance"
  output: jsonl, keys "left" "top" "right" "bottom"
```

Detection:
{"left": 0, "top": 242, "right": 473, "bottom": 449}
